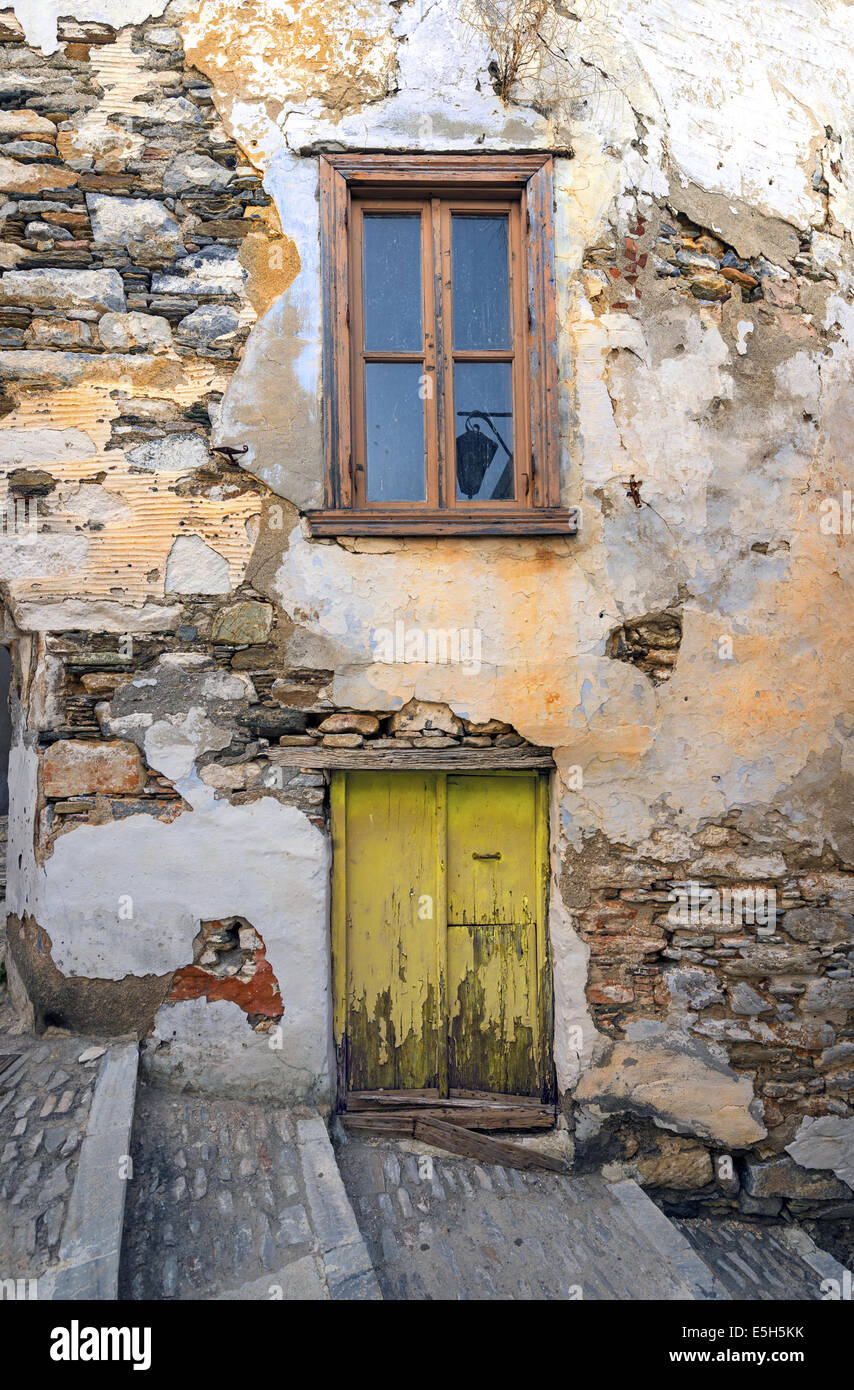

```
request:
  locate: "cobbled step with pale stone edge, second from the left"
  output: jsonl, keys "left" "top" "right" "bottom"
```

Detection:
{"left": 120, "top": 1084, "right": 380, "bottom": 1300}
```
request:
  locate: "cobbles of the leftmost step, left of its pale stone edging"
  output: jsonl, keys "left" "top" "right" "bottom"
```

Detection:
{"left": 0, "top": 1006, "right": 106, "bottom": 1297}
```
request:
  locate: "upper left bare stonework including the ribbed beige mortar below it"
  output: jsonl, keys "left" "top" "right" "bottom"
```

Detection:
{"left": 0, "top": 11, "right": 282, "bottom": 599}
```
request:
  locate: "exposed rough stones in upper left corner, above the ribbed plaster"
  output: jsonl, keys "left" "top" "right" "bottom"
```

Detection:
{"left": 0, "top": 11, "right": 270, "bottom": 364}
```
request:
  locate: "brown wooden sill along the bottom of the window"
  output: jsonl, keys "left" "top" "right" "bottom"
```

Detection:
{"left": 306, "top": 507, "right": 579, "bottom": 538}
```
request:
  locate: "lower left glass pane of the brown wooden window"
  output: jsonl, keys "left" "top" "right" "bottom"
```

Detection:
{"left": 364, "top": 361, "right": 426, "bottom": 502}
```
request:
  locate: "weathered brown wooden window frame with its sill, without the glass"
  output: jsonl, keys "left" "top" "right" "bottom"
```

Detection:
{"left": 307, "top": 154, "right": 577, "bottom": 537}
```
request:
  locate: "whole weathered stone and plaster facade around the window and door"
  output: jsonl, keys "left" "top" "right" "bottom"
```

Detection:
{"left": 0, "top": 0, "right": 854, "bottom": 1215}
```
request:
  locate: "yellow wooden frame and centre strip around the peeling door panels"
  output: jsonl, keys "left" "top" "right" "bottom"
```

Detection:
{"left": 330, "top": 767, "right": 556, "bottom": 1111}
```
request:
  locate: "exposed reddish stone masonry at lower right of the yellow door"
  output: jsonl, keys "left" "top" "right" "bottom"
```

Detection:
{"left": 574, "top": 813, "right": 854, "bottom": 1215}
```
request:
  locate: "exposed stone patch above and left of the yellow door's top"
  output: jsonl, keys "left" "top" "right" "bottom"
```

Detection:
{"left": 40, "top": 614, "right": 540, "bottom": 842}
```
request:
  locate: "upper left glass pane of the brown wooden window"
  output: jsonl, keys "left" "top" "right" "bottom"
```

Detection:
{"left": 364, "top": 213, "right": 423, "bottom": 352}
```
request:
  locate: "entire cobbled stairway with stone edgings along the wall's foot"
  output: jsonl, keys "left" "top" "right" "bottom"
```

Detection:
{"left": 0, "top": 967, "right": 850, "bottom": 1301}
